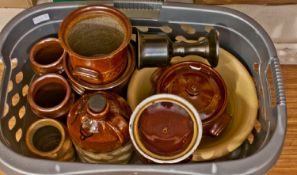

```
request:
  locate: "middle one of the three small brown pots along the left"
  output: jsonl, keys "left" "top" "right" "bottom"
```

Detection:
{"left": 27, "top": 73, "right": 74, "bottom": 118}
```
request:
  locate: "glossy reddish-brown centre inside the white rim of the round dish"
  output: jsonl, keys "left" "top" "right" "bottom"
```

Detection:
{"left": 139, "top": 102, "right": 193, "bottom": 156}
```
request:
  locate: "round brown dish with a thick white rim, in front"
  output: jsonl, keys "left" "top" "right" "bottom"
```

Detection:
{"left": 129, "top": 94, "right": 202, "bottom": 163}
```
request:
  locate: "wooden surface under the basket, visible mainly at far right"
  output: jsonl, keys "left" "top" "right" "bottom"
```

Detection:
{"left": 0, "top": 63, "right": 297, "bottom": 172}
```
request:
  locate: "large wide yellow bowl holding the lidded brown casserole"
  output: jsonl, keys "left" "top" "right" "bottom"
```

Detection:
{"left": 127, "top": 49, "right": 258, "bottom": 161}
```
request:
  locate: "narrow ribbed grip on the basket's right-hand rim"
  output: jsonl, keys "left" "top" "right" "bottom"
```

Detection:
{"left": 270, "top": 57, "right": 286, "bottom": 106}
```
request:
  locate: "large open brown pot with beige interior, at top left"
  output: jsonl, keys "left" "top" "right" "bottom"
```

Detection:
{"left": 59, "top": 5, "right": 132, "bottom": 84}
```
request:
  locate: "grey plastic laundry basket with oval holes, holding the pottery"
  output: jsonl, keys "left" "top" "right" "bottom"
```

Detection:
{"left": 0, "top": 1, "right": 287, "bottom": 174}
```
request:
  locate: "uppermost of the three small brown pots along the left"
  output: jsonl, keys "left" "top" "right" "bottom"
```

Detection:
{"left": 30, "top": 38, "right": 66, "bottom": 75}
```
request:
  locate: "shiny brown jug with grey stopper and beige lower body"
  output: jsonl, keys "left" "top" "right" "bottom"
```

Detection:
{"left": 67, "top": 91, "right": 132, "bottom": 163}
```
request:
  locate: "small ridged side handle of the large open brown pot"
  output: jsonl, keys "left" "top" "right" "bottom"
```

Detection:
{"left": 72, "top": 67, "right": 102, "bottom": 82}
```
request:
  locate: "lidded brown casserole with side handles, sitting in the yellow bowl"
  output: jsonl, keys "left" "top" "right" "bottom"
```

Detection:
{"left": 152, "top": 61, "right": 231, "bottom": 136}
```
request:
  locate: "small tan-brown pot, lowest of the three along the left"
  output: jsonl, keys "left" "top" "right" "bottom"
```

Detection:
{"left": 26, "top": 119, "right": 75, "bottom": 161}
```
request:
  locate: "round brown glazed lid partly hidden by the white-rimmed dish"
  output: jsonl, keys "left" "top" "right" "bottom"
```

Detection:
{"left": 157, "top": 61, "right": 226, "bottom": 120}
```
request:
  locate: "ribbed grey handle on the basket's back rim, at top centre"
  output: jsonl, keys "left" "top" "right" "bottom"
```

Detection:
{"left": 113, "top": 0, "right": 164, "bottom": 19}
